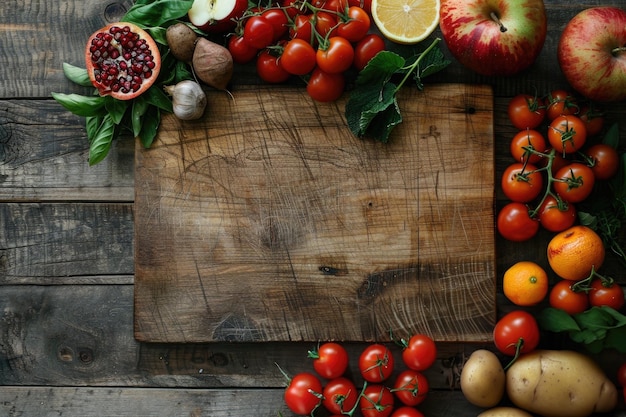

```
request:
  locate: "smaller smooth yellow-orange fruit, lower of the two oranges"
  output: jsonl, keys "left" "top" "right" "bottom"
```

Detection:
{"left": 502, "top": 261, "right": 548, "bottom": 306}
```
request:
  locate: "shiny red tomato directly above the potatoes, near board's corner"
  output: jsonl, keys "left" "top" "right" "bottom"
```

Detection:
{"left": 493, "top": 310, "right": 539, "bottom": 356}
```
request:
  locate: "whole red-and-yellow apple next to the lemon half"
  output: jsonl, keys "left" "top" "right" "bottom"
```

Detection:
{"left": 439, "top": 0, "right": 547, "bottom": 75}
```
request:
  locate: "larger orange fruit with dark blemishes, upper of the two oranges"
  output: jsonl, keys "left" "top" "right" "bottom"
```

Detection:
{"left": 548, "top": 226, "right": 605, "bottom": 281}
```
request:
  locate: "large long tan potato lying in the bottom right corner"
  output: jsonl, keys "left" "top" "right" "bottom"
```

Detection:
{"left": 506, "top": 350, "right": 617, "bottom": 417}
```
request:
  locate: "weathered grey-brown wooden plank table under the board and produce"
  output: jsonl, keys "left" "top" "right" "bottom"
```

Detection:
{"left": 0, "top": 0, "right": 626, "bottom": 416}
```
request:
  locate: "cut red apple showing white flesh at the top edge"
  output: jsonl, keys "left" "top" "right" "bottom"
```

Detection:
{"left": 187, "top": 0, "right": 248, "bottom": 33}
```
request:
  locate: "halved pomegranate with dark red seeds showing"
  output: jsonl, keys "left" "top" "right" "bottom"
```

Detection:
{"left": 85, "top": 22, "right": 161, "bottom": 100}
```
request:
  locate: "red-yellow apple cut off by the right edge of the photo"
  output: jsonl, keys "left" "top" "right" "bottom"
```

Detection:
{"left": 557, "top": 7, "right": 626, "bottom": 101}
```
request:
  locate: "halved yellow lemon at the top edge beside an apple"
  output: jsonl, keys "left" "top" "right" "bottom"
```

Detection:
{"left": 372, "top": 0, "right": 441, "bottom": 44}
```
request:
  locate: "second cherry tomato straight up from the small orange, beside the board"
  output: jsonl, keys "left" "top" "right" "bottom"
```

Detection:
{"left": 500, "top": 162, "right": 543, "bottom": 203}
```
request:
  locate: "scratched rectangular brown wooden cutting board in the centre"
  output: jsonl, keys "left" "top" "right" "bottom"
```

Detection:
{"left": 135, "top": 84, "right": 496, "bottom": 342}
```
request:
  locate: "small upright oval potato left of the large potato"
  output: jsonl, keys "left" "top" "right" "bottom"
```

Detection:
{"left": 461, "top": 349, "right": 506, "bottom": 408}
